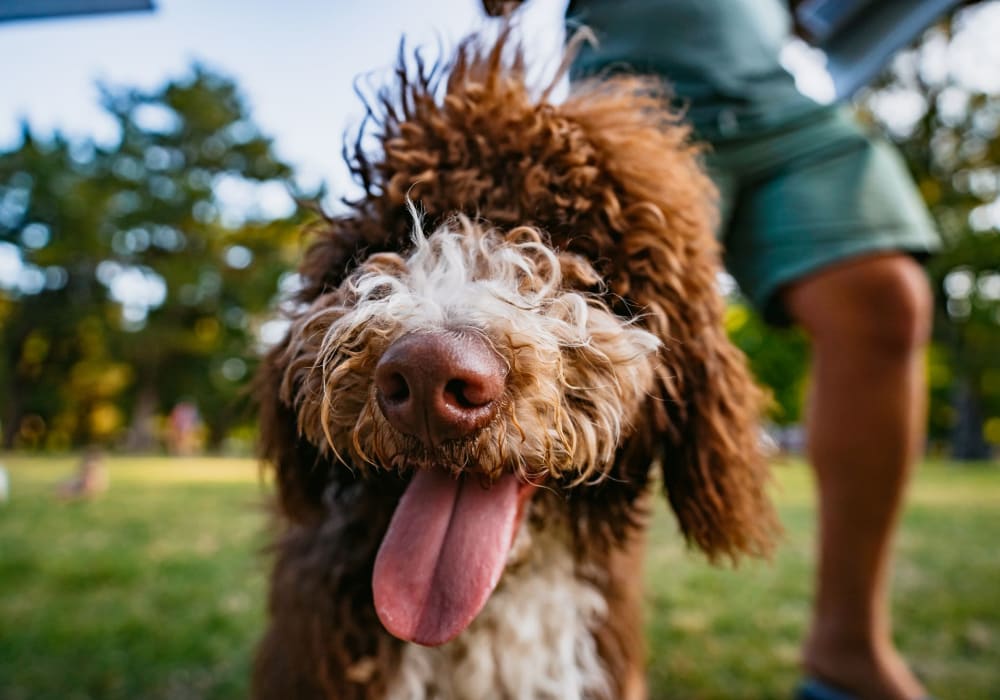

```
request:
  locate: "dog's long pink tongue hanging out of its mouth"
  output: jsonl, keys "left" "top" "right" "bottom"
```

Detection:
{"left": 372, "top": 469, "right": 530, "bottom": 646}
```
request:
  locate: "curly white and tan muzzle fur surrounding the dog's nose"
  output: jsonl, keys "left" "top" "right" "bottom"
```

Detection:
{"left": 280, "top": 217, "right": 659, "bottom": 482}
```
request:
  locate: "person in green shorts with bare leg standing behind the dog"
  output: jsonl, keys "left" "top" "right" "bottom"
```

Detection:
{"left": 484, "top": 0, "right": 938, "bottom": 700}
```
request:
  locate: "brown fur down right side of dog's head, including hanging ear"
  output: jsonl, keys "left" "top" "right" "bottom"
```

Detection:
{"left": 561, "top": 77, "right": 778, "bottom": 558}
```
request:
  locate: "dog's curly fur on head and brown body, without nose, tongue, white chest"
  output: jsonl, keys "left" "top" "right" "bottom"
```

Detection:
{"left": 255, "top": 29, "right": 776, "bottom": 698}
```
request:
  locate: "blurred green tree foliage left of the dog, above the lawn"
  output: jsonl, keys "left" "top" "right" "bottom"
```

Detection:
{"left": 0, "top": 67, "right": 306, "bottom": 448}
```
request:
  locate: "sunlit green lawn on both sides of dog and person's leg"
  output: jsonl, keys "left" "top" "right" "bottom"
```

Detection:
{"left": 0, "top": 456, "right": 1000, "bottom": 700}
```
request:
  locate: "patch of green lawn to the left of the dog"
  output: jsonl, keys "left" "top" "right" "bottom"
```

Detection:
{"left": 0, "top": 458, "right": 264, "bottom": 700}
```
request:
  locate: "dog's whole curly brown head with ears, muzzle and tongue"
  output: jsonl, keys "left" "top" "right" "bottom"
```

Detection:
{"left": 259, "top": 32, "right": 774, "bottom": 643}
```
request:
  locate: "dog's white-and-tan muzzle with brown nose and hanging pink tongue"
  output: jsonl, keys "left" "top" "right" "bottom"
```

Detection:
{"left": 282, "top": 217, "right": 659, "bottom": 644}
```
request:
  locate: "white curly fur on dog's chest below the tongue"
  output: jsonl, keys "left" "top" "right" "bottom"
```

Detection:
{"left": 387, "top": 526, "right": 611, "bottom": 700}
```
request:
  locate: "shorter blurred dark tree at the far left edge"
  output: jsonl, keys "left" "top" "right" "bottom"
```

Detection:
{"left": 0, "top": 127, "right": 127, "bottom": 447}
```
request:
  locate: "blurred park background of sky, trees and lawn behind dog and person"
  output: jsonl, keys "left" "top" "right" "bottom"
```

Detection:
{"left": 0, "top": 0, "right": 1000, "bottom": 699}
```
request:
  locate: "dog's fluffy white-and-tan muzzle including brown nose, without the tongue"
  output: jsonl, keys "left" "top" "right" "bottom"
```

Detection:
{"left": 283, "top": 217, "right": 659, "bottom": 483}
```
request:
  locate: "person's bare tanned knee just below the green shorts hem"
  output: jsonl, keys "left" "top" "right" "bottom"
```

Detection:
{"left": 786, "top": 255, "right": 933, "bottom": 354}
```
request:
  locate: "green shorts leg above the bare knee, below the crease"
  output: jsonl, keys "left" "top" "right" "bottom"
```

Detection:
{"left": 706, "top": 108, "right": 939, "bottom": 325}
